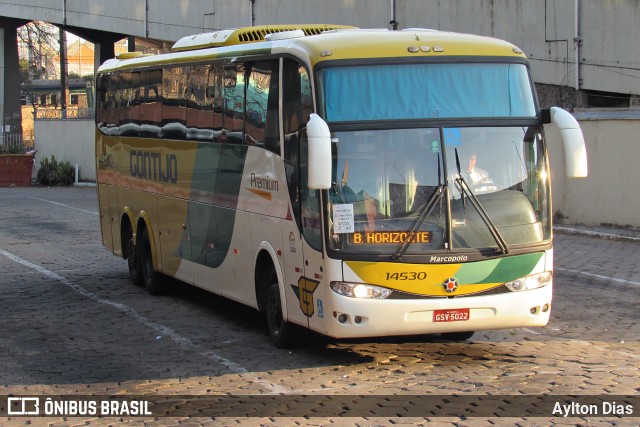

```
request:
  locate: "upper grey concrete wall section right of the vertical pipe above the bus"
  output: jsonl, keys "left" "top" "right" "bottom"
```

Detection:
{"left": 397, "top": 0, "right": 640, "bottom": 95}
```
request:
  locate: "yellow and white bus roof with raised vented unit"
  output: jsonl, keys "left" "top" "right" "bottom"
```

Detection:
{"left": 99, "top": 25, "right": 525, "bottom": 72}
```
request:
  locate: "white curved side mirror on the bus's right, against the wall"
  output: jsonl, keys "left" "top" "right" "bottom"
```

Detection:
{"left": 550, "top": 107, "right": 588, "bottom": 178}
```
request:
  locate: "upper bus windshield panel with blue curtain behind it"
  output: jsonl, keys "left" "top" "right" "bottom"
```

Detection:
{"left": 321, "top": 63, "right": 536, "bottom": 123}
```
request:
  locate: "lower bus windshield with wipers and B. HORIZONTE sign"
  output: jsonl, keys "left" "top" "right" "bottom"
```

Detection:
{"left": 329, "top": 126, "right": 550, "bottom": 255}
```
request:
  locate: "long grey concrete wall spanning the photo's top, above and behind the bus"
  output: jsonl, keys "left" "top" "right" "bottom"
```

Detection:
{"left": 0, "top": 0, "right": 640, "bottom": 95}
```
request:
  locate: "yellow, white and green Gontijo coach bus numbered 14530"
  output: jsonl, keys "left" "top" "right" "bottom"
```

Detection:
{"left": 95, "top": 25, "right": 587, "bottom": 347}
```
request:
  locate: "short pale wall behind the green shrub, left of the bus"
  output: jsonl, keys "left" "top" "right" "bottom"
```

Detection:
{"left": 34, "top": 119, "right": 96, "bottom": 182}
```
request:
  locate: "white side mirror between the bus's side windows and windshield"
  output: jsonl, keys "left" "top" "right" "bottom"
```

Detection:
{"left": 307, "top": 114, "right": 331, "bottom": 190}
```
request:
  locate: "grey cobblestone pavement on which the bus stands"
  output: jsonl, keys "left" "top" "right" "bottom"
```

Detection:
{"left": 0, "top": 187, "right": 640, "bottom": 426}
